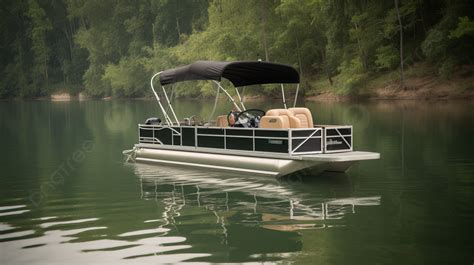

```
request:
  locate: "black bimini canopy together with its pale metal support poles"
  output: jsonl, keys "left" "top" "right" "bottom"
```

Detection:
{"left": 150, "top": 61, "right": 300, "bottom": 124}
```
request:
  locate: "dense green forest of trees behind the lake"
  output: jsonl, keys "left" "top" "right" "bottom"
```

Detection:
{"left": 0, "top": 0, "right": 474, "bottom": 98}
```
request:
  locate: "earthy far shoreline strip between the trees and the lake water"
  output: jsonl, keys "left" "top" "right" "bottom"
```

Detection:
{"left": 0, "top": 64, "right": 474, "bottom": 102}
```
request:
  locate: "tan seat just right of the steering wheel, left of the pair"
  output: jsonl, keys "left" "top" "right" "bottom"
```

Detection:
{"left": 260, "top": 109, "right": 300, "bottom": 129}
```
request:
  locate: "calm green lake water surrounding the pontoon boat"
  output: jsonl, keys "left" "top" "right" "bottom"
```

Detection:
{"left": 0, "top": 101, "right": 474, "bottom": 265}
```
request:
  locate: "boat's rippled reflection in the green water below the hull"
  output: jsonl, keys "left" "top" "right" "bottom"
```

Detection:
{"left": 133, "top": 164, "right": 381, "bottom": 262}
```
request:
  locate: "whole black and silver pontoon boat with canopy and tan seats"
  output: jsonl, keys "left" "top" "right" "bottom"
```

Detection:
{"left": 124, "top": 61, "right": 380, "bottom": 177}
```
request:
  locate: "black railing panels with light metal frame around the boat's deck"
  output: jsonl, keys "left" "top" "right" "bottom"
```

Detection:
{"left": 139, "top": 124, "right": 352, "bottom": 156}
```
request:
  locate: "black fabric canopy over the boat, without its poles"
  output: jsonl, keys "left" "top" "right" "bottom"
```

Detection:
{"left": 160, "top": 61, "right": 300, "bottom": 87}
